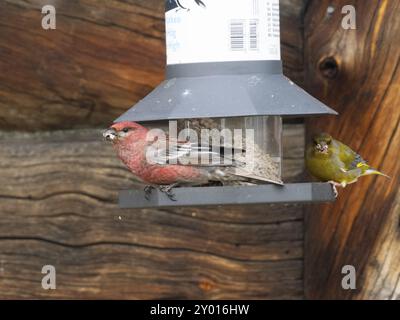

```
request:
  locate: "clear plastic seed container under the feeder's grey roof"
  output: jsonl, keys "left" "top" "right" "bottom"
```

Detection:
{"left": 178, "top": 116, "right": 282, "bottom": 183}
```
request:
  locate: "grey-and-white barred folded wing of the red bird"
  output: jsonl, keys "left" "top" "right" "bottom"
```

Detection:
{"left": 146, "top": 139, "right": 242, "bottom": 167}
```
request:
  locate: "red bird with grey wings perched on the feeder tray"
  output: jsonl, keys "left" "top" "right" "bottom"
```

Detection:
{"left": 103, "top": 121, "right": 282, "bottom": 201}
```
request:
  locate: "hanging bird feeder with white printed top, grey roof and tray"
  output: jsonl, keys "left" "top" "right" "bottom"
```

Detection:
{"left": 115, "top": 0, "right": 337, "bottom": 208}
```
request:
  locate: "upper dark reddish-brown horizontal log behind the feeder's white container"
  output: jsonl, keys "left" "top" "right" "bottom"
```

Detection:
{"left": 0, "top": 0, "right": 303, "bottom": 131}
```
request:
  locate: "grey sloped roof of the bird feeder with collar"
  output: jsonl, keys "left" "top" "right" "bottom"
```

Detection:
{"left": 115, "top": 60, "right": 337, "bottom": 122}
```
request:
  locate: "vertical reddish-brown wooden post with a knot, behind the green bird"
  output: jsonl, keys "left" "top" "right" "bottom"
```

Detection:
{"left": 305, "top": 0, "right": 400, "bottom": 299}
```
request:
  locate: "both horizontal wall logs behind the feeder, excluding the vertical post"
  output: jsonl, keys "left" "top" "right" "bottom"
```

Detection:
{"left": 0, "top": 0, "right": 304, "bottom": 299}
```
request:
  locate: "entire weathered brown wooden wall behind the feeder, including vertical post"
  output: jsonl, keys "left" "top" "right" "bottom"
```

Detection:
{"left": 0, "top": 0, "right": 400, "bottom": 299}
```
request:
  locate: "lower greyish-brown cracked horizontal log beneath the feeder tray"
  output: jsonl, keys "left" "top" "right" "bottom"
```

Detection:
{"left": 0, "top": 125, "right": 304, "bottom": 299}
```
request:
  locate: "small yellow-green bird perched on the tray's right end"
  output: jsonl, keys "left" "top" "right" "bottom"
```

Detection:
{"left": 306, "top": 133, "right": 389, "bottom": 197}
